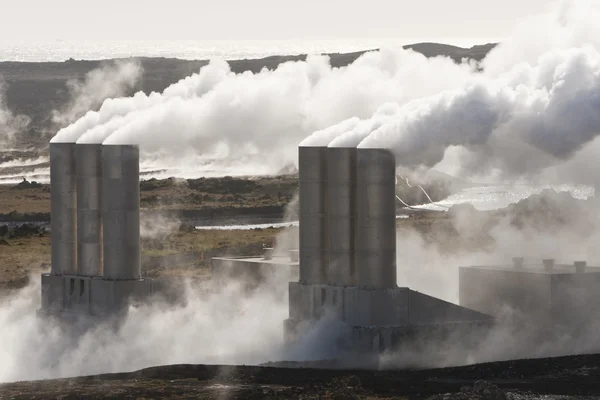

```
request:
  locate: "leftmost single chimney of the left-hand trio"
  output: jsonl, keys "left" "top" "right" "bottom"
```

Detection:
{"left": 50, "top": 143, "right": 77, "bottom": 275}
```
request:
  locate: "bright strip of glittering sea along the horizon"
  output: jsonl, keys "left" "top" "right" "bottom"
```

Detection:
{"left": 0, "top": 37, "right": 494, "bottom": 62}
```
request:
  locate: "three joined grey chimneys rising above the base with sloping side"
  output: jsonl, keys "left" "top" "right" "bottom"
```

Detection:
{"left": 298, "top": 146, "right": 396, "bottom": 289}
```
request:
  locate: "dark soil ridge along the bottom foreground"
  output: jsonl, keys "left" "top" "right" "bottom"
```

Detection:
{"left": 0, "top": 355, "right": 600, "bottom": 400}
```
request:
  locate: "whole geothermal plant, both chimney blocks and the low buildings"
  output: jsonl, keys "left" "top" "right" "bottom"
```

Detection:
{"left": 39, "top": 138, "right": 600, "bottom": 353}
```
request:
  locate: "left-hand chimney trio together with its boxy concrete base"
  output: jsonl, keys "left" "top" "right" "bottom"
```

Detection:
{"left": 39, "top": 143, "right": 153, "bottom": 318}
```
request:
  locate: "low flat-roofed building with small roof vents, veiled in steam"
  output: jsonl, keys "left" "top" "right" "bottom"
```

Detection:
{"left": 459, "top": 257, "right": 600, "bottom": 331}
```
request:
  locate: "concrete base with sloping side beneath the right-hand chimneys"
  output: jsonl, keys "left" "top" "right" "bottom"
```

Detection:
{"left": 284, "top": 282, "right": 493, "bottom": 353}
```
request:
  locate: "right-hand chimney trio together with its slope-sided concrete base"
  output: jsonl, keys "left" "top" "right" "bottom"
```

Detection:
{"left": 284, "top": 146, "right": 492, "bottom": 352}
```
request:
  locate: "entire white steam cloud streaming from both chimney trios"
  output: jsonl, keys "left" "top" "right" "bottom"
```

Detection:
{"left": 53, "top": 1, "right": 600, "bottom": 188}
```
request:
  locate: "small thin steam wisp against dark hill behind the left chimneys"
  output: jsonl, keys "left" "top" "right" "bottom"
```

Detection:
{"left": 52, "top": 61, "right": 142, "bottom": 137}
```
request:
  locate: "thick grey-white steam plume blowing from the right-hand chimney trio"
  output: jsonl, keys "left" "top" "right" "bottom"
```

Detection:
{"left": 360, "top": 47, "right": 600, "bottom": 182}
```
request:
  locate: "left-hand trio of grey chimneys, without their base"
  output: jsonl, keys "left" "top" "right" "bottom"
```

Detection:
{"left": 50, "top": 143, "right": 141, "bottom": 280}
